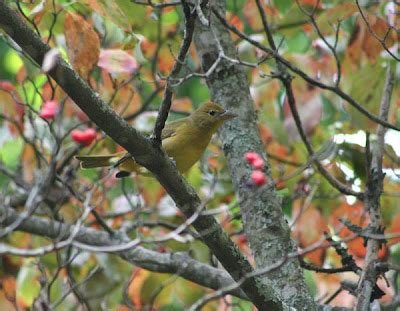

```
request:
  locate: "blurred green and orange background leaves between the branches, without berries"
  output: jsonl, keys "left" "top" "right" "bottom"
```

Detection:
{"left": 0, "top": 0, "right": 400, "bottom": 310}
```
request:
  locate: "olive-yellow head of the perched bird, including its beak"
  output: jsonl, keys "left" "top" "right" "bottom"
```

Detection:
{"left": 191, "top": 102, "right": 237, "bottom": 131}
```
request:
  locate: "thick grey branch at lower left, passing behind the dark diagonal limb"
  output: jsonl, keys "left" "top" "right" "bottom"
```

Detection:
{"left": 0, "top": 206, "right": 247, "bottom": 299}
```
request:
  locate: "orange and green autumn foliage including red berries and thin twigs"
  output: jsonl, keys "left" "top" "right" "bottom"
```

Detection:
{"left": 0, "top": 0, "right": 400, "bottom": 311}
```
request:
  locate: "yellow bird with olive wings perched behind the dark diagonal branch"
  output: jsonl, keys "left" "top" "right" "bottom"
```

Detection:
{"left": 76, "top": 102, "right": 237, "bottom": 178}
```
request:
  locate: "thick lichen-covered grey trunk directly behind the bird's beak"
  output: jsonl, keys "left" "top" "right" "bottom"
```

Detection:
{"left": 194, "top": 1, "right": 316, "bottom": 310}
